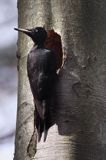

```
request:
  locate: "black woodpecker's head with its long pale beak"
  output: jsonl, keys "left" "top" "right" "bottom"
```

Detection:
{"left": 14, "top": 27, "right": 47, "bottom": 46}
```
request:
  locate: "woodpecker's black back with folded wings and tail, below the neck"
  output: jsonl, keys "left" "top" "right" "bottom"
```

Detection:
{"left": 27, "top": 51, "right": 57, "bottom": 140}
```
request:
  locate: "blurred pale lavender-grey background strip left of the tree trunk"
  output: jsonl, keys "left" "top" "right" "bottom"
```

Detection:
{"left": 0, "top": 0, "right": 17, "bottom": 160}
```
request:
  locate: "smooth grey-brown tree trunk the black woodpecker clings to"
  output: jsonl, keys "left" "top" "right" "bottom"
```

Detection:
{"left": 14, "top": 0, "right": 106, "bottom": 160}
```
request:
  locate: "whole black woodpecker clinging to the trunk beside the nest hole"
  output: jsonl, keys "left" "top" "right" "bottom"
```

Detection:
{"left": 15, "top": 27, "right": 57, "bottom": 141}
